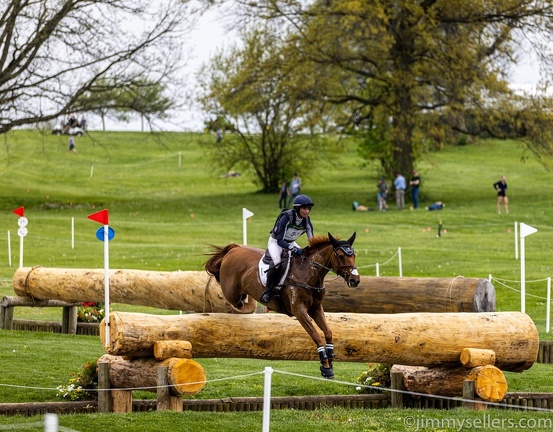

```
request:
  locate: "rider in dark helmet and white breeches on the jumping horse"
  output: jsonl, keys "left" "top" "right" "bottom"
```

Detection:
{"left": 259, "top": 195, "right": 315, "bottom": 303}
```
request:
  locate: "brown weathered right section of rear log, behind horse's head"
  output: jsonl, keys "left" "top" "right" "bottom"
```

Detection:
{"left": 323, "top": 276, "right": 495, "bottom": 314}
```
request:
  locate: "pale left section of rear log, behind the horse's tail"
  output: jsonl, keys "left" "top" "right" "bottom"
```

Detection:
{"left": 13, "top": 267, "right": 239, "bottom": 312}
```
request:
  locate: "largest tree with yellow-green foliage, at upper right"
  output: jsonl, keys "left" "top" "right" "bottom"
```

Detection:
{"left": 224, "top": 0, "right": 553, "bottom": 175}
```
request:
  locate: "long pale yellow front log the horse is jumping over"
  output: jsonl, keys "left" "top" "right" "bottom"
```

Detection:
{"left": 100, "top": 312, "right": 539, "bottom": 371}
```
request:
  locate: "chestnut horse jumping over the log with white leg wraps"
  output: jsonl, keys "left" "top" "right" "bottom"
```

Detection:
{"left": 205, "top": 233, "right": 361, "bottom": 378}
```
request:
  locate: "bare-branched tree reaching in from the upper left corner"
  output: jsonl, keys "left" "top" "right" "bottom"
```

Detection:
{"left": 0, "top": 0, "right": 203, "bottom": 132}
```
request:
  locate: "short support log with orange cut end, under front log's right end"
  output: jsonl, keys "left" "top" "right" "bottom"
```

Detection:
{"left": 392, "top": 365, "right": 508, "bottom": 402}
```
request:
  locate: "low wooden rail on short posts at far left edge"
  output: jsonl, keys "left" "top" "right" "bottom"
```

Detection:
{"left": 0, "top": 296, "right": 81, "bottom": 334}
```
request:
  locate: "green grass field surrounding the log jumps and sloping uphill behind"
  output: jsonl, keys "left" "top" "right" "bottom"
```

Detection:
{"left": 0, "top": 131, "right": 553, "bottom": 431}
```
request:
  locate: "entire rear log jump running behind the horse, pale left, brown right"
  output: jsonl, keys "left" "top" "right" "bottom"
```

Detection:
{"left": 13, "top": 267, "right": 495, "bottom": 313}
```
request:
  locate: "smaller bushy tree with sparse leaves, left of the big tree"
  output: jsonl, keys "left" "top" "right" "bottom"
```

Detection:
{"left": 198, "top": 26, "right": 336, "bottom": 192}
